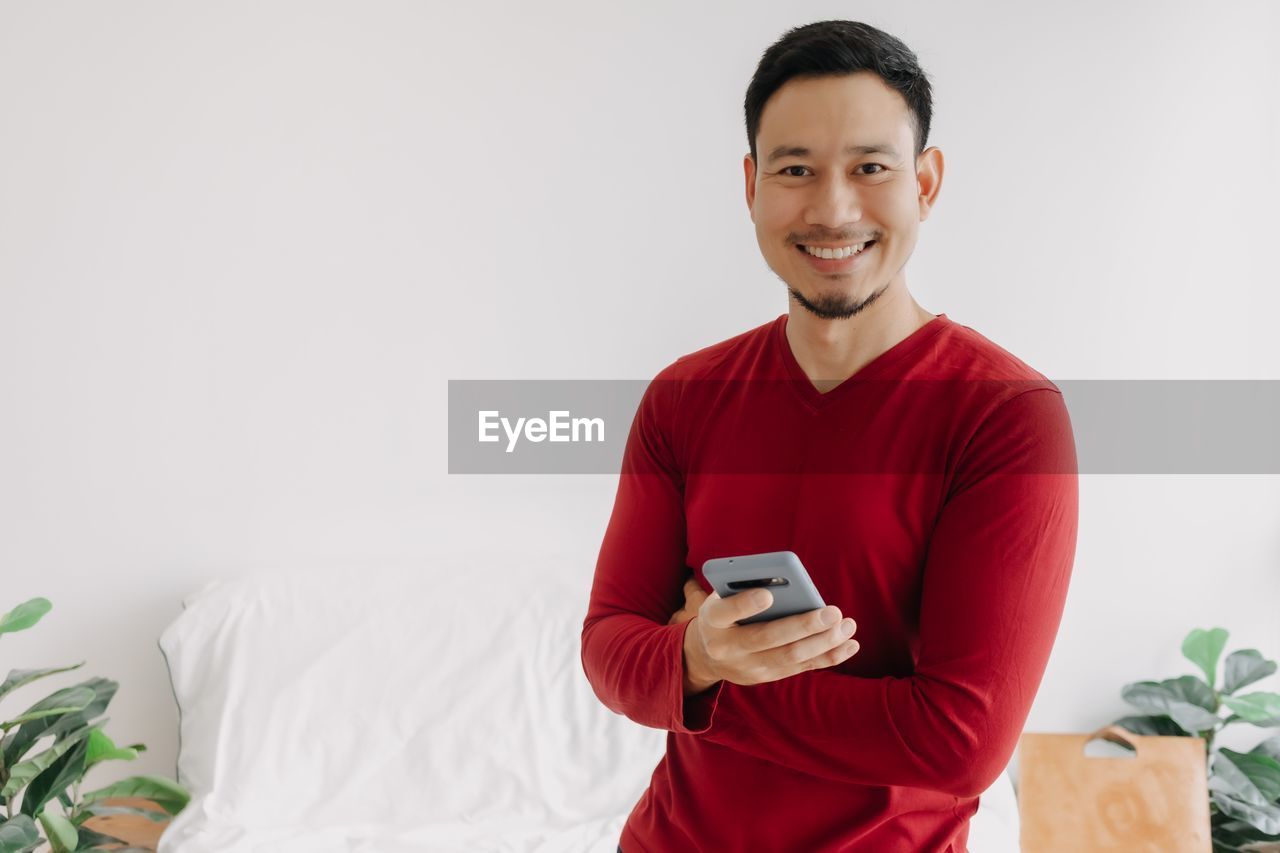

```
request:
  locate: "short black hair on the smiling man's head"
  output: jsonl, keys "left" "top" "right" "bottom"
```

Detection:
{"left": 742, "top": 20, "right": 933, "bottom": 163}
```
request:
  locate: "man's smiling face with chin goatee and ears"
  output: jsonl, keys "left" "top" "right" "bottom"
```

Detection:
{"left": 744, "top": 72, "right": 942, "bottom": 319}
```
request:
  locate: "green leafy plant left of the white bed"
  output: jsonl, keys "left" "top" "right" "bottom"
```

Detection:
{"left": 0, "top": 598, "right": 191, "bottom": 853}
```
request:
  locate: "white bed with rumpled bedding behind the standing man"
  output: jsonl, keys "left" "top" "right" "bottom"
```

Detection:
{"left": 157, "top": 551, "right": 1018, "bottom": 853}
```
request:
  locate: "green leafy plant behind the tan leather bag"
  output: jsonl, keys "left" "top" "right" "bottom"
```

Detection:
{"left": 1114, "top": 628, "right": 1280, "bottom": 853}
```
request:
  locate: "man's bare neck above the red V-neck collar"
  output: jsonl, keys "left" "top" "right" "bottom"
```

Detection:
{"left": 786, "top": 287, "right": 934, "bottom": 393}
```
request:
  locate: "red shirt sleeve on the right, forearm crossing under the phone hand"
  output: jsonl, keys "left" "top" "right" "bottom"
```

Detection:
{"left": 703, "top": 387, "right": 1078, "bottom": 797}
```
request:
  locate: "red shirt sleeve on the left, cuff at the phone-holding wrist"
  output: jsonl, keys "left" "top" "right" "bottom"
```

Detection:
{"left": 581, "top": 361, "right": 721, "bottom": 734}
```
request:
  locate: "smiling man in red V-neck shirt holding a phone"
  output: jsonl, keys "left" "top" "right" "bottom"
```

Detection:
{"left": 582, "top": 20, "right": 1078, "bottom": 853}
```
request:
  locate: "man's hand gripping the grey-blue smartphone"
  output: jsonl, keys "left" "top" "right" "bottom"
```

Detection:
{"left": 685, "top": 589, "right": 859, "bottom": 695}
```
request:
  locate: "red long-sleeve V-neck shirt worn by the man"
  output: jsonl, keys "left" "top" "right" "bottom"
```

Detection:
{"left": 581, "top": 314, "right": 1078, "bottom": 853}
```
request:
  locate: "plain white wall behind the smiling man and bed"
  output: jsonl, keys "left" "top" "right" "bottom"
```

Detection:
{"left": 0, "top": 0, "right": 1280, "bottom": 781}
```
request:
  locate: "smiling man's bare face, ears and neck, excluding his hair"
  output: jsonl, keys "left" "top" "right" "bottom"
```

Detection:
{"left": 742, "top": 70, "right": 942, "bottom": 391}
